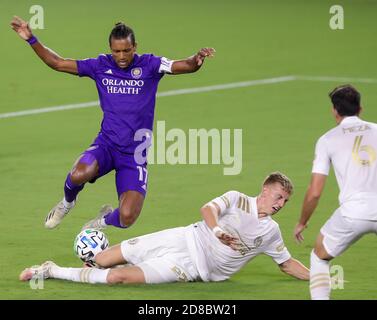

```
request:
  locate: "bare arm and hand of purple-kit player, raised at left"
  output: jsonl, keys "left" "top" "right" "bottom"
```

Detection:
{"left": 11, "top": 16, "right": 78, "bottom": 74}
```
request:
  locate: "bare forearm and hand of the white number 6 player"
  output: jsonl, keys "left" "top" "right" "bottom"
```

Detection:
{"left": 294, "top": 173, "right": 327, "bottom": 242}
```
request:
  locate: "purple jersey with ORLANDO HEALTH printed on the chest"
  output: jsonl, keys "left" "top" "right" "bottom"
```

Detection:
{"left": 77, "top": 54, "right": 166, "bottom": 153}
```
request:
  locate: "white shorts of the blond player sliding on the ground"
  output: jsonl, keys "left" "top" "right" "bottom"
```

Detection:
{"left": 121, "top": 227, "right": 200, "bottom": 283}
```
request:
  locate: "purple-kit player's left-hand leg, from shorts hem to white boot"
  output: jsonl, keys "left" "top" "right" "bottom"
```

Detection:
{"left": 45, "top": 154, "right": 99, "bottom": 229}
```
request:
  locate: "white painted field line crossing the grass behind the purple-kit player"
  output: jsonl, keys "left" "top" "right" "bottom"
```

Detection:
{"left": 0, "top": 76, "right": 377, "bottom": 119}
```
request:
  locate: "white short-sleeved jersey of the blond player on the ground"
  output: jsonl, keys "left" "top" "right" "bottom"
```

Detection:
{"left": 186, "top": 191, "right": 291, "bottom": 281}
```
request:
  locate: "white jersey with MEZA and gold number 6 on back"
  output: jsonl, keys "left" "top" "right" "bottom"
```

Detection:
{"left": 312, "top": 116, "right": 377, "bottom": 220}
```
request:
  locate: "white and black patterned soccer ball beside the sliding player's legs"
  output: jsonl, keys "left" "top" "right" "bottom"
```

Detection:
{"left": 73, "top": 229, "right": 109, "bottom": 266}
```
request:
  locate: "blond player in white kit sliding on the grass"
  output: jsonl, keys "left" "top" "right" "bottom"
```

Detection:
{"left": 20, "top": 172, "right": 309, "bottom": 284}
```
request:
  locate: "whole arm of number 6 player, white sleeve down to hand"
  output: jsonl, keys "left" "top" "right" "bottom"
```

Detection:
{"left": 294, "top": 136, "right": 331, "bottom": 242}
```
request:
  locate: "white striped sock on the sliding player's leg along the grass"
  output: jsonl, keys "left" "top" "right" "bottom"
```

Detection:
{"left": 51, "top": 267, "right": 110, "bottom": 283}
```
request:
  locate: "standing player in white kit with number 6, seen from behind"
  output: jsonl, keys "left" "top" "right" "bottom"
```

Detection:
{"left": 294, "top": 85, "right": 377, "bottom": 300}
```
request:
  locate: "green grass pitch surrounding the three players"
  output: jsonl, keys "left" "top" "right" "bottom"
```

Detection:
{"left": 0, "top": 0, "right": 377, "bottom": 299}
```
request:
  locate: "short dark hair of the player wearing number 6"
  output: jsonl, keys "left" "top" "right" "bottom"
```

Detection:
{"left": 329, "top": 84, "right": 361, "bottom": 117}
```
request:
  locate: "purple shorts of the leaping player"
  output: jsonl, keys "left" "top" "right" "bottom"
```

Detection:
{"left": 79, "top": 141, "right": 148, "bottom": 198}
